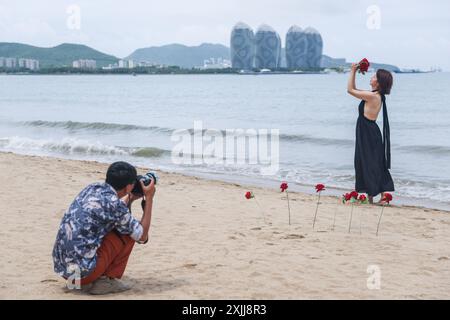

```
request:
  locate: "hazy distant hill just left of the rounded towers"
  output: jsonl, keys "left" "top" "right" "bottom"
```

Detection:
{"left": 126, "top": 43, "right": 230, "bottom": 68}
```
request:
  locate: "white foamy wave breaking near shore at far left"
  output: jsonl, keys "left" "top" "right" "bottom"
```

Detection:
{"left": 0, "top": 137, "right": 170, "bottom": 158}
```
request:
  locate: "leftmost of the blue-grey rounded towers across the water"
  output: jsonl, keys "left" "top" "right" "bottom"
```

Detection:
{"left": 230, "top": 22, "right": 255, "bottom": 70}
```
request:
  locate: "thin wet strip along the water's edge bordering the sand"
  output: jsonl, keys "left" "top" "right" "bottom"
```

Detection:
{"left": 0, "top": 151, "right": 450, "bottom": 214}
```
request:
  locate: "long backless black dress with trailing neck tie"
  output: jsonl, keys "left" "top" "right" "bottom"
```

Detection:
{"left": 355, "top": 95, "right": 394, "bottom": 197}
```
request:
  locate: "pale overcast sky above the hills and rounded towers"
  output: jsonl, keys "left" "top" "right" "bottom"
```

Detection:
{"left": 0, "top": 0, "right": 450, "bottom": 71}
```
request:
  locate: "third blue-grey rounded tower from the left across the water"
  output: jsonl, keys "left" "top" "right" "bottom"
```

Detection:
{"left": 286, "top": 26, "right": 309, "bottom": 69}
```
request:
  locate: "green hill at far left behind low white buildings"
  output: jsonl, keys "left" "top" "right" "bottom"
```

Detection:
{"left": 0, "top": 42, "right": 118, "bottom": 68}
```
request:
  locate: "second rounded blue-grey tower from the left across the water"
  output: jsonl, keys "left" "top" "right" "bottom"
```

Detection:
{"left": 255, "top": 24, "right": 281, "bottom": 70}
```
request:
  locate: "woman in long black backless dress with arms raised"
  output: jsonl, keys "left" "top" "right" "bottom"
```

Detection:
{"left": 347, "top": 64, "right": 394, "bottom": 203}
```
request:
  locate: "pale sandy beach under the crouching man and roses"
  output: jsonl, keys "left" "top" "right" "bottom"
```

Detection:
{"left": 0, "top": 153, "right": 450, "bottom": 299}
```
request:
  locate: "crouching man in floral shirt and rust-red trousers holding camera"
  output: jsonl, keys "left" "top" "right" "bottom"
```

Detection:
{"left": 53, "top": 162, "right": 155, "bottom": 294}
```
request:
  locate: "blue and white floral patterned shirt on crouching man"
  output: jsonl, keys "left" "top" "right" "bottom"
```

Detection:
{"left": 53, "top": 183, "right": 143, "bottom": 278}
